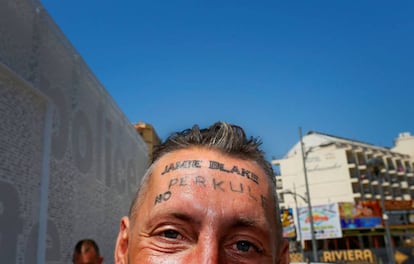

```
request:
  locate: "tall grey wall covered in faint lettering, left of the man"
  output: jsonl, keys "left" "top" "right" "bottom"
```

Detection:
{"left": 0, "top": 0, "right": 147, "bottom": 264}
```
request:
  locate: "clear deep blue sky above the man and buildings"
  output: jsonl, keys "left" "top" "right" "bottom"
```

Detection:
{"left": 41, "top": 0, "right": 414, "bottom": 158}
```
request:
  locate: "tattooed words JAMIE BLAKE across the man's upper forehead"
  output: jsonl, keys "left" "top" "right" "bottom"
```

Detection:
{"left": 161, "top": 160, "right": 259, "bottom": 184}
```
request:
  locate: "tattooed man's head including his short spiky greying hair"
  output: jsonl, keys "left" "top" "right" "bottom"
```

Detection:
{"left": 114, "top": 122, "right": 289, "bottom": 264}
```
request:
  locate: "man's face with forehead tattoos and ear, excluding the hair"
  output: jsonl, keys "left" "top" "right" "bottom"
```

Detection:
{"left": 115, "top": 149, "right": 286, "bottom": 264}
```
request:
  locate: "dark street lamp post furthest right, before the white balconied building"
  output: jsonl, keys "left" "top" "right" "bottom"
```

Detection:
{"left": 367, "top": 158, "right": 395, "bottom": 264}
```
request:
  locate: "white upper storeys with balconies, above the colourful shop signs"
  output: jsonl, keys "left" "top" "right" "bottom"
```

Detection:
{"left": 272, "top": 131, "right": 414, "bottom": 210}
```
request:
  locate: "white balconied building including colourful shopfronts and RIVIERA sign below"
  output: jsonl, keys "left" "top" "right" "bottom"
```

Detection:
{"left": 272, "top": 132, "right": 414, "bottom": 263}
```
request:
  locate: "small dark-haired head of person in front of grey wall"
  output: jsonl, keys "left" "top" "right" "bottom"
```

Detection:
{"left": 72, "top": 239, "right": 103, "bottom": 264}
